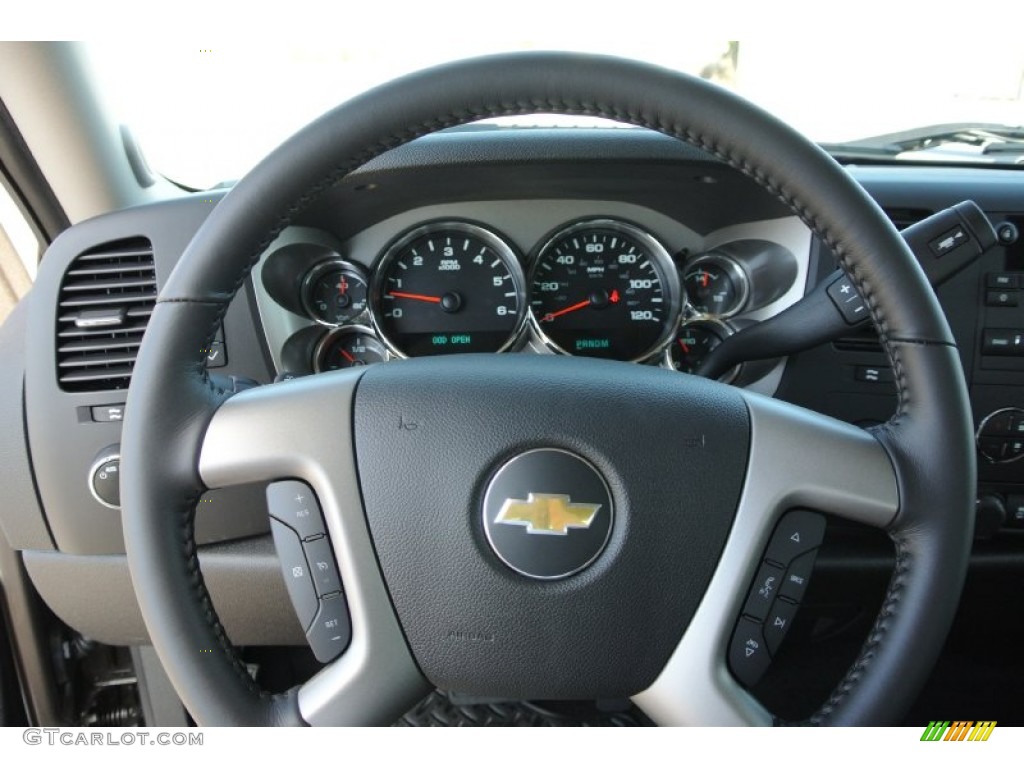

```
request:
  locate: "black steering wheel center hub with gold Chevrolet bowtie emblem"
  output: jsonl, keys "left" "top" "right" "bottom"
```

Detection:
{"left": 353, "top": 355, "right": 750, "bottom": 698}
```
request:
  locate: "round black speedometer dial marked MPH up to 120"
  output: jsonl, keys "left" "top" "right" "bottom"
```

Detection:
{"left": 529, "top": 219, "right": 681, "bottom": 361}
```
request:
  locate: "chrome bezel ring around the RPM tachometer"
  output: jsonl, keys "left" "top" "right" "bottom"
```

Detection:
{"left": 367, "top": 219, "right": 527, "bottom": 359}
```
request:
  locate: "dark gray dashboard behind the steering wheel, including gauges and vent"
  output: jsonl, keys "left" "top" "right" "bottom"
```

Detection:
{"left": 6, "top": 129, "right": 1024, "bottom": 722}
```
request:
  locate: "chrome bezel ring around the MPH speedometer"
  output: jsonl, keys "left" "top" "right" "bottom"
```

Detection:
{"left": 526, "top": 218, "right": 684, "bottom": 362}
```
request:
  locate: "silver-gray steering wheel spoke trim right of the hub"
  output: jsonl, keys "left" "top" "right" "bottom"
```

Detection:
{"left": 633, "top": 392, "right": 899, "bottom": 726}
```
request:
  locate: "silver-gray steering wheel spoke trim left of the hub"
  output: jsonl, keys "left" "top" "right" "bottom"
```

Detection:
{"left": 199, "top": 370, "right": 429, "bottom": 725}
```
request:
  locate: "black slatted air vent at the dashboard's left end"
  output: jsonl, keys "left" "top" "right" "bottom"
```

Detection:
{"left": 56, "top": 238, "right": 157, "bottom": 392}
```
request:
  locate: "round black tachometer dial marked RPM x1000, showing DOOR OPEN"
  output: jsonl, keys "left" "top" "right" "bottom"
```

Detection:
{"left": 371, "top": 222, "right": 525, "bottom": 357}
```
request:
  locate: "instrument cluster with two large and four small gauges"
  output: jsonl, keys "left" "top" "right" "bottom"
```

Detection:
{"left": 261, "top": 217, "right": 798, "bottom": 381}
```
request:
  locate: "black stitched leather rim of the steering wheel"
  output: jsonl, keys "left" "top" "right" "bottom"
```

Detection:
{"left": 122, "top": 53, "right": 975, "bottom": 725}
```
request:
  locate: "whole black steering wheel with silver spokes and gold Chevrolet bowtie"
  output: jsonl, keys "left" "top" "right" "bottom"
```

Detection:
{"left": 122, "top": 53, "right": 975, "bottom": 725}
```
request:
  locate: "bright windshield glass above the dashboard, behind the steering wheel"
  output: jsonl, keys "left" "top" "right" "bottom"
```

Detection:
{"left": 88, "top": 39, "right": 1024, "bottom": 188}
